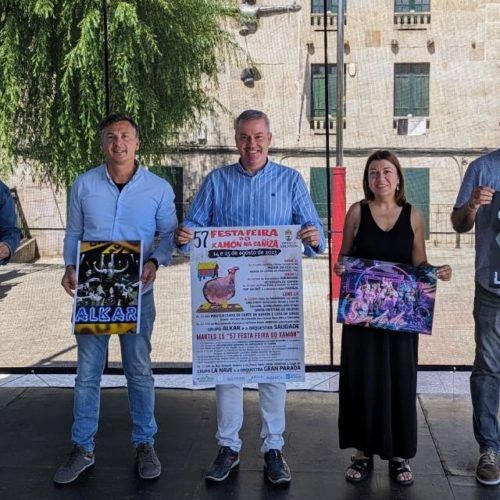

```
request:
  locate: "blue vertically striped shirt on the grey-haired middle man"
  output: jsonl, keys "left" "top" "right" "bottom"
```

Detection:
{"left": 182, "top": 161, "right": 326, "bottom": 252}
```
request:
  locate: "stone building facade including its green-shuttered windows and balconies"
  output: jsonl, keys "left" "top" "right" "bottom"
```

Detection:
{"left": 7, "top": 0, "right": 500, "bottom": 254}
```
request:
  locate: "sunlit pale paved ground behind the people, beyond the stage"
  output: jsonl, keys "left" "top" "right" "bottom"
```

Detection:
{"left": 0, "top": 245, "right": 473, "bottom": 368}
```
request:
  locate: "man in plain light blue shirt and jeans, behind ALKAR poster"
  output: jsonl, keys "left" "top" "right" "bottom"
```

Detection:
{"left": 54, "top": 114, "right": 177, "bottom": 484}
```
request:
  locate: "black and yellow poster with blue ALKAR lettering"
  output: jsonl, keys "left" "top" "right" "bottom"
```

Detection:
{"left": 72, "top": 241, "right": 142, "bottom": 335}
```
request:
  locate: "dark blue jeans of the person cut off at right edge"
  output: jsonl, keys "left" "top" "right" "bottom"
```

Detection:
{"left": 470, "top": 283, "right": 500, "bottom": 453}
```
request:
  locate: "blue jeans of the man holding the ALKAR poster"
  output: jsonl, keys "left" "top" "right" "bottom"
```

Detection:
{"left": 71, "top": 291, "right": 158, "bottom": 451}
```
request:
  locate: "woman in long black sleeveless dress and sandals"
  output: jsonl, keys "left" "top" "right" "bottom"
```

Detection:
{"left": 334, "top": 151, "right": 451, "bottom": 485}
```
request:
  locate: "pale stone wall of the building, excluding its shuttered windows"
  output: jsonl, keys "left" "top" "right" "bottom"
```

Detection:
{"left": 4, "top": 0, "right": 500, "bottom": 255}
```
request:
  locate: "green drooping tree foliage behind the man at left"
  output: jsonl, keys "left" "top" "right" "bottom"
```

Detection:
{"left": 0, "top": 0, "right": 237, "bottom": 185}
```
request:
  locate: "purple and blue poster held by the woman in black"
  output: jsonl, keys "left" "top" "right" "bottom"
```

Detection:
{"left": 337, "top": 257, "right": 437, "bottom": 335}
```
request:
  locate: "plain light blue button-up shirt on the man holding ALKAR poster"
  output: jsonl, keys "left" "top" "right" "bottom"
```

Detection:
{"left": 64, "top": 165, "right": 177, "bottom": 291}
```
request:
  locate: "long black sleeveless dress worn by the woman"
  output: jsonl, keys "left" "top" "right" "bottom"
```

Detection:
{"left": 338, "top": 203, "right": 418, "bottom": 460}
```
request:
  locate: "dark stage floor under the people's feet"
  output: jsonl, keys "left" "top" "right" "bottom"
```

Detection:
{"left": 0, "top": 388, "right": 500, "bottom": 500}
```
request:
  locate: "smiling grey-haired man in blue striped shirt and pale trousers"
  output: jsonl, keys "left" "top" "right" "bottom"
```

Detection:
{"left": 176, "top": 110, "right": 326, "bottom": 484}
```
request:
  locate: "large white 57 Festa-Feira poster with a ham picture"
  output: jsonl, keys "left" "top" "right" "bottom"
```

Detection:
{"left": 191, "top": 226, "right": 305, "bottom": 385}
